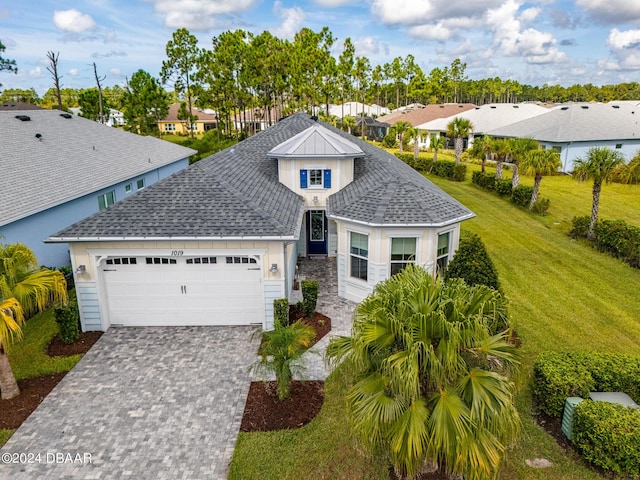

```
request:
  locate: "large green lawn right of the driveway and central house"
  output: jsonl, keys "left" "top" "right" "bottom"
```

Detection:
{"left": 229, "top": 165, "right": 640, "bottom": 480}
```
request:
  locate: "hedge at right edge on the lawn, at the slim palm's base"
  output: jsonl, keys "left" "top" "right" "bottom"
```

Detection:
{"left": 569, "top": 216, "right": 640, "bottom": 268}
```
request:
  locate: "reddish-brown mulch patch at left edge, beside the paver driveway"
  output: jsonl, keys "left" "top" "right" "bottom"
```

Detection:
{"left": 0, "top": 373, "right": 66, "bottom": 429}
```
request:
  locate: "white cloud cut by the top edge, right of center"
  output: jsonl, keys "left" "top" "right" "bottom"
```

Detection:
{"left": 371, "top": 0, "right": 504, "bottom": 25}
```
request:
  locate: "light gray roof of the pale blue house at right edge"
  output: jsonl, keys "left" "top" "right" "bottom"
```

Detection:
{"left": 487, "top": 102, "right": 640, "bottom": 143}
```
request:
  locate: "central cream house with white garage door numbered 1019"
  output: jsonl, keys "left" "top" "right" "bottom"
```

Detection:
{"left": 48, "top": 113, "right": 473, "bottom": 330}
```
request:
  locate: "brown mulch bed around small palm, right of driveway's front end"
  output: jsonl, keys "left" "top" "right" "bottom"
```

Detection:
{"left": 240, "top": 381, "right": 324, "bottom": 432}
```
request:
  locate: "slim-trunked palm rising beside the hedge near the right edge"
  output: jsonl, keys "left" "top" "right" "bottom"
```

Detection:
{"left": 573, "top": 147, "right": 625, "bottom": 239}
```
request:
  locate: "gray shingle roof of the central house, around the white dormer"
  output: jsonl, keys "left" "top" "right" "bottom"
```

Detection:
{"left": 52, "top": 113, "right": 473, "bottom": 240}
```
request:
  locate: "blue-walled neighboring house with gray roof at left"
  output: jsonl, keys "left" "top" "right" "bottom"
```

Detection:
{"left": 0, "top": 109, "right": 195, "bottom": 267}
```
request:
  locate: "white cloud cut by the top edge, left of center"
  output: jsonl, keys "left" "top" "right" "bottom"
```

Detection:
{"left": 147, "top": 0, "right": 256, "bottom": 30}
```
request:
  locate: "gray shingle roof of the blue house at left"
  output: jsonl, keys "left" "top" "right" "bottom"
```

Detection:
{"left": 0, "top": 109, "right": 195, "bottom": 225}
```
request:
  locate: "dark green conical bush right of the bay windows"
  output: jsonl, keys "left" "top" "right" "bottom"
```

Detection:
{"left": 445, "top": 231, "right": 500, "bottom": 290}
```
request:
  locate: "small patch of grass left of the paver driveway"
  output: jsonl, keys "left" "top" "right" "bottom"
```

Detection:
{"left": 0, "top": 294, "right": 82, "bottom": 446}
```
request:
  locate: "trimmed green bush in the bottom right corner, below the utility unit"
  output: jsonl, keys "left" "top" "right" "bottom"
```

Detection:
{"left": 573, "top": 400, "right": 640, "bottom": 478}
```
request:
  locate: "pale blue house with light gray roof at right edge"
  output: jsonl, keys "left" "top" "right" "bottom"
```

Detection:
{"left": 487, "top": 102, "right": 640, "bottom": 172}
